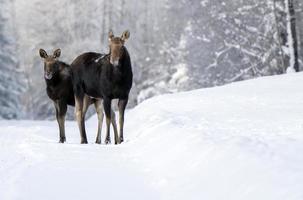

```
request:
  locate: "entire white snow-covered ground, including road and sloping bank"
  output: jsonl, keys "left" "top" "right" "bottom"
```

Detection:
{"left": 0, "top": 73, "right": 303, "bottom": 200}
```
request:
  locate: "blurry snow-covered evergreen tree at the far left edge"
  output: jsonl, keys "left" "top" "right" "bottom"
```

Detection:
{"left": 0, "top": 0, "right": 25, "bottom": 119}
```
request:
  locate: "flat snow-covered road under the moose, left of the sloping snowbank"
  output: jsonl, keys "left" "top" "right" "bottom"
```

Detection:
{"left": 0, "top": 121, "right": 155, "bottom": 200}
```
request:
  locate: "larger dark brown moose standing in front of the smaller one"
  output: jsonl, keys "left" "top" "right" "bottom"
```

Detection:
{"left": 71, "top": 31, "right": 133, "bottom": 144}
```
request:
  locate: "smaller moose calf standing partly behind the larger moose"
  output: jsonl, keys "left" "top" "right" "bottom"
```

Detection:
{"left": 39, "top": 49, "right": 117, "bottom": 143}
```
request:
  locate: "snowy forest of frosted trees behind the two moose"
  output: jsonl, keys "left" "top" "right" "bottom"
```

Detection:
{"left": 0, "top": 0, "right": 303, "bottom": 119}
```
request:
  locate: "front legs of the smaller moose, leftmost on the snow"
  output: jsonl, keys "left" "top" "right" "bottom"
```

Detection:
{"left": 54, "top": 101, "right": 67, "bottom": 143}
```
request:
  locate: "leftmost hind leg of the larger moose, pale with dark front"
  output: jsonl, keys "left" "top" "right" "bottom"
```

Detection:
{"left": 75, "top": 96, "right": 87, "bottom": 144}
